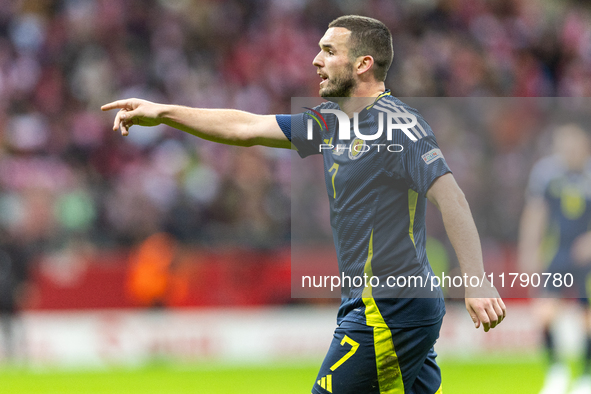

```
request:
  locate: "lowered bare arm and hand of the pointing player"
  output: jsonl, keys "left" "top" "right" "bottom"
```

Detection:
{"left": 427, "top": 173, "right": 507, "bottom": 331}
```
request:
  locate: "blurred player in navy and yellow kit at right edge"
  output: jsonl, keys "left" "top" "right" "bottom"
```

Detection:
{"left": 519, "top": 124, "right": 591, "bottom": 394}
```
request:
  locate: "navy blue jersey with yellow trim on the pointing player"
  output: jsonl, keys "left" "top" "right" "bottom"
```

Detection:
{"left": 277, "top": 91, "right": 450, "bottom": 327}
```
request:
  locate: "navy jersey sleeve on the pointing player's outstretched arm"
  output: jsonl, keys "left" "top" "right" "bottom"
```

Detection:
{"left": 275, "top": 112, "right": 322, "bottom": 158}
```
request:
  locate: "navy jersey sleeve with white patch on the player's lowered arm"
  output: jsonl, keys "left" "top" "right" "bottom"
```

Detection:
{"left": 402, "top": 135, "right": 451, "bottom": 196}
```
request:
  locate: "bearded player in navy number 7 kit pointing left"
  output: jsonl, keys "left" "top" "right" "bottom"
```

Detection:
{"left": 102, "top": 15, "right": 506, "bottom": 394}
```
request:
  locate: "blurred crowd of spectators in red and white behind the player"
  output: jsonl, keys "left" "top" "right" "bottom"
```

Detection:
{"left": 0, "top": 0, "right": 591, "bottom": 304}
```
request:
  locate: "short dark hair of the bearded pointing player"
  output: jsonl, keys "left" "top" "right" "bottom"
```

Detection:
{"left": 328, "top": 15, "right": 394, "bottom": 81}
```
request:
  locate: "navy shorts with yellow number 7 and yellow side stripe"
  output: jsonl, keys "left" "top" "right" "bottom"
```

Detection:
{"left": 312, "top": 321, "right": 442, "bottom": 394}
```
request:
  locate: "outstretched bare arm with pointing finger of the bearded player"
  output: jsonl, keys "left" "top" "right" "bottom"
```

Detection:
{"left": 101, "top": 99, "right": 291, "bottom": 149}
